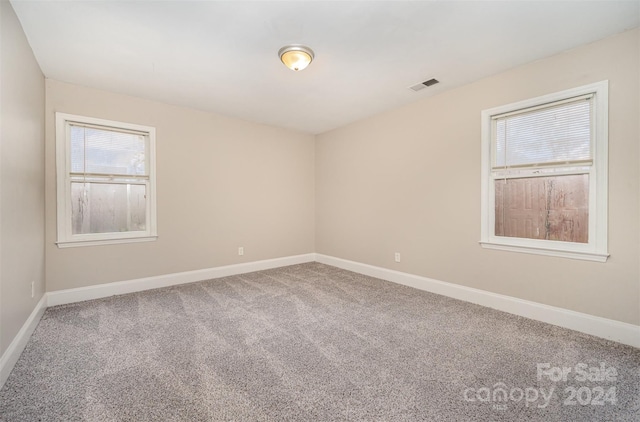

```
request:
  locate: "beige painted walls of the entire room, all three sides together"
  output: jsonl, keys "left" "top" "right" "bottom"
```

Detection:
{"left": 0, "top": 8, "right": 640, "bottom": 360}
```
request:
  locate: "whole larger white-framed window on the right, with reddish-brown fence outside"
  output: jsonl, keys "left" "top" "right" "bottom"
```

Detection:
{"left": 480, "top": 81, "right": 608, "bottom": 262}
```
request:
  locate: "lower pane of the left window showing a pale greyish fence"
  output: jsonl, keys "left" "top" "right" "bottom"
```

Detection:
{"left": 71, "top": 182, "right": 147, "bottom": 234}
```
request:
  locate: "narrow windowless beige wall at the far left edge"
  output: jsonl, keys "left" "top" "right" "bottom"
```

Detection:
{"left": 0, "top": 0, "right": 45, "bottom": 356}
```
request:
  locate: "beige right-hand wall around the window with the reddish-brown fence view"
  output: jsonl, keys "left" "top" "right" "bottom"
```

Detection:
{"left": 316, "top": 29, "right": 640, "bottom": 324}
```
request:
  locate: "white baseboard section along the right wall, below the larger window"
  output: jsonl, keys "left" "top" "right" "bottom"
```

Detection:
{"left": 316, "top": 254, "right": 640, "bottom": 348}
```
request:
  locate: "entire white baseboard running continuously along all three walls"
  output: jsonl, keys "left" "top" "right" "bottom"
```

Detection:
{"left": 0, "top": 253, "right": 640, "bottom": 388}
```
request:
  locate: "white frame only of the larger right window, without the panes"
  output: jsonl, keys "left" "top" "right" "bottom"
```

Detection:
{"left": 480, "top": 81, "right": 609, "bottom": 262}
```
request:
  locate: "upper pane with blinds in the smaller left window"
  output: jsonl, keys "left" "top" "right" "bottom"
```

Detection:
{"left": 70, "top": 125, "right": 147, "bottom": 175}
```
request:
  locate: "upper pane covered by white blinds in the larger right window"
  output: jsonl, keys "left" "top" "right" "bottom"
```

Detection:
{"left": 495, "top": 99, "right": 591, "bottom": 167}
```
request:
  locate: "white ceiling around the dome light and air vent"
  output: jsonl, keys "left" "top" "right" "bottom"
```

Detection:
{"left": 11, "top": 0, "right": 640, "bottom": 134}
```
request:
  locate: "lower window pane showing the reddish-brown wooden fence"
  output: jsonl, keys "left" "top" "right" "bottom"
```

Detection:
{"left": 495, "top": 174, "right": 589, "bottom": 243}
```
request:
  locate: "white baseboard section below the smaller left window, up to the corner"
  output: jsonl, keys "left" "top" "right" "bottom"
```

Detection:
{"left": 47, "top": 253, "right": 315, "bottom": 306}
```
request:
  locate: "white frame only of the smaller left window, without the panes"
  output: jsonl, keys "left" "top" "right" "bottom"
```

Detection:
{"left": 56, "top": 113, "right": 158, "bottom": 248}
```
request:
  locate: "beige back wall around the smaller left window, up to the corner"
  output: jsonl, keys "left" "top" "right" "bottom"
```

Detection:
{"left": 46, "top": 79, "right": 314, "bottom": 291}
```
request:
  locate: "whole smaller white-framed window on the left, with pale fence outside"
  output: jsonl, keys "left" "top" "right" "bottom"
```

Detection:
{"left": 56, "top": 113, "right": 157, "bottom": 247}
